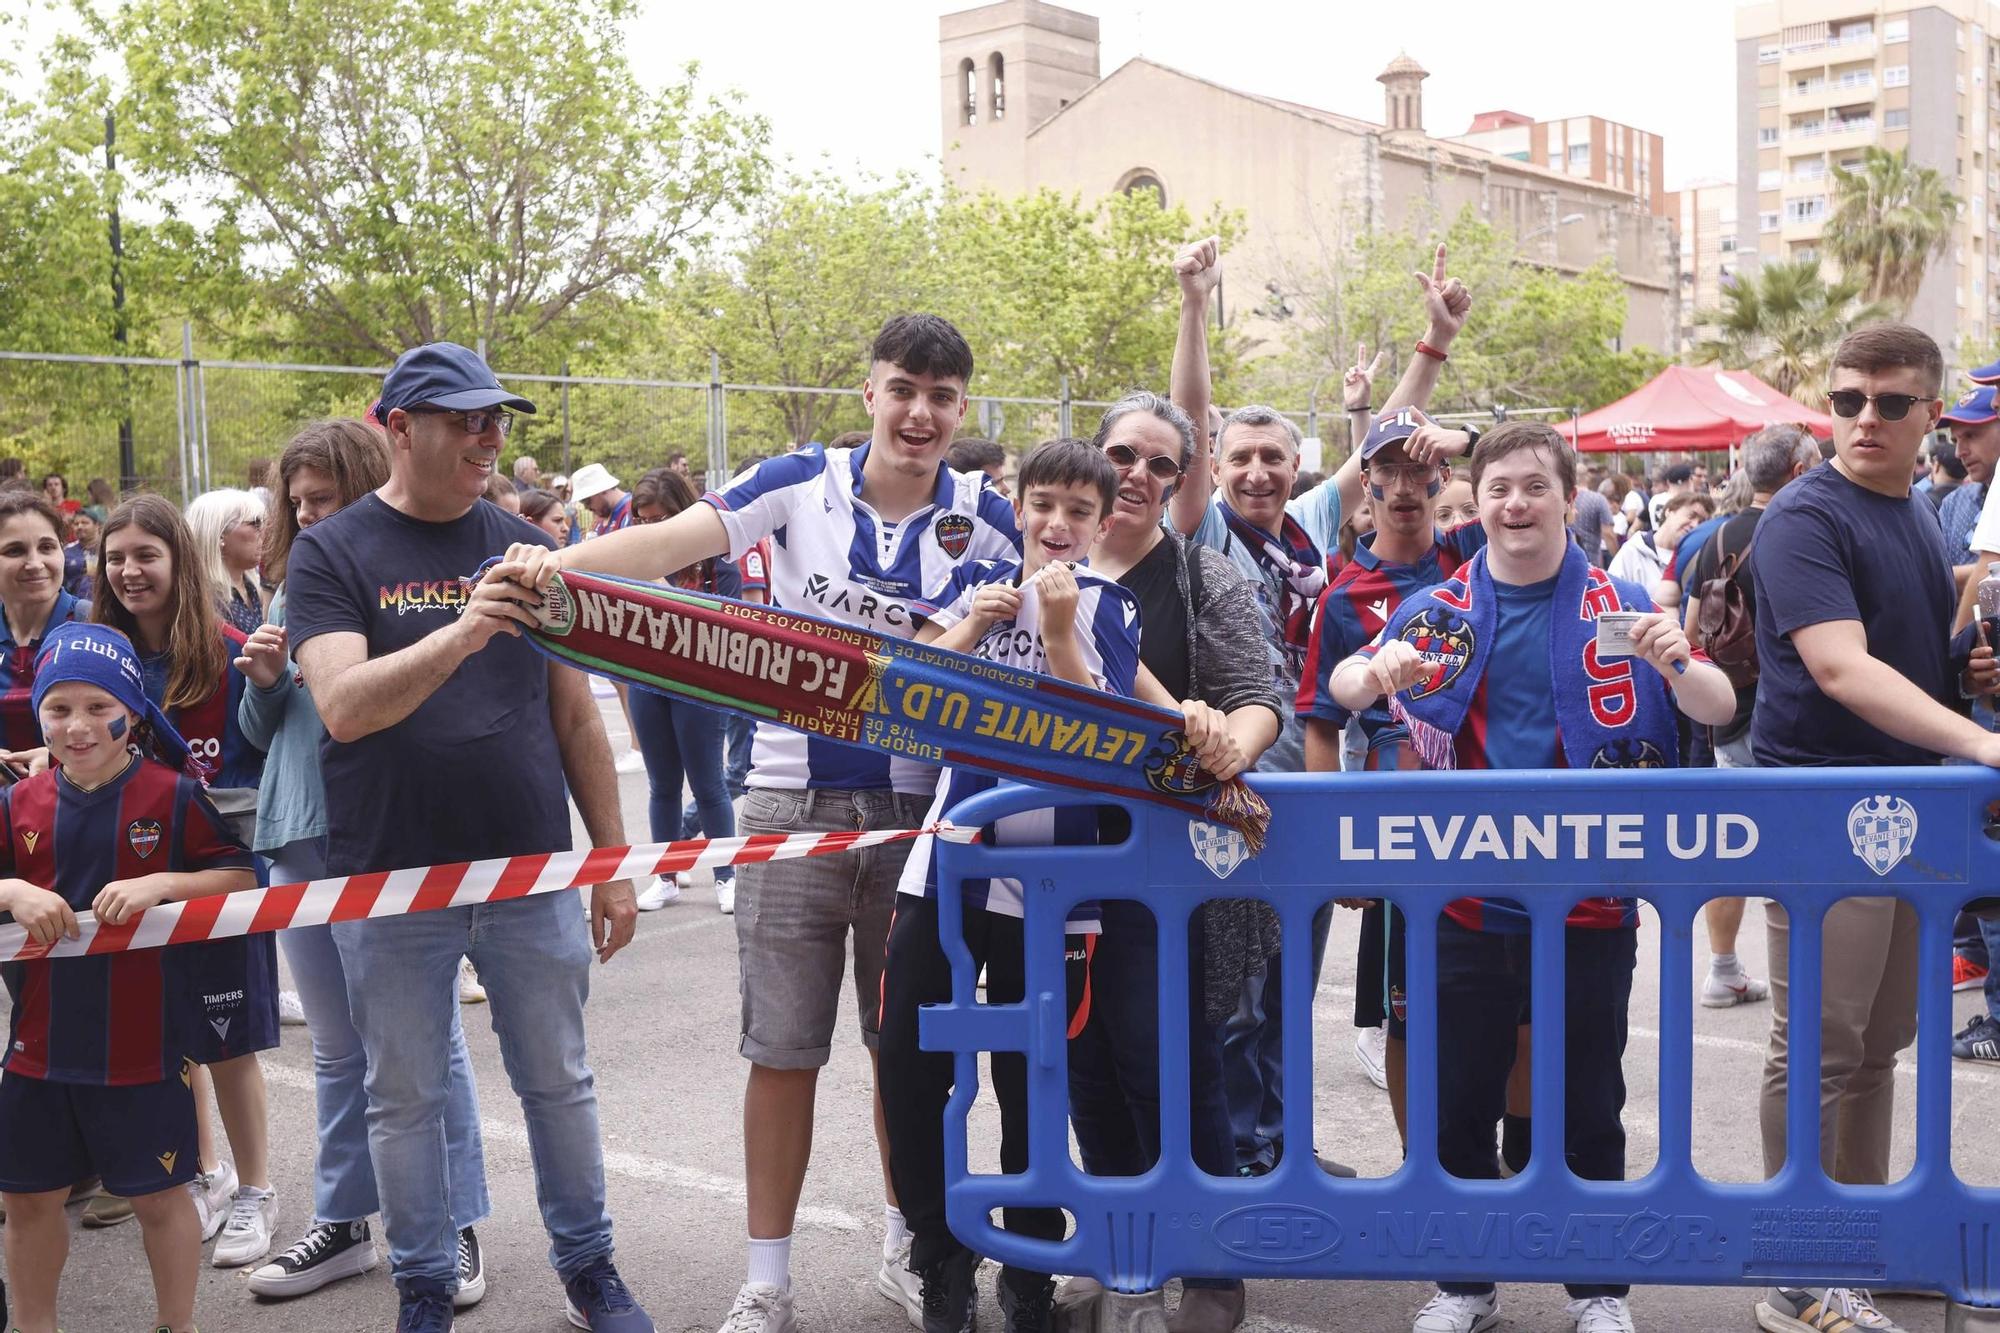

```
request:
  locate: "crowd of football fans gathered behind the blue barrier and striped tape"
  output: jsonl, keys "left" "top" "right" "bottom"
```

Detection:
{"left": 0, "top": 238, "right": 2000, "bottom": 1333}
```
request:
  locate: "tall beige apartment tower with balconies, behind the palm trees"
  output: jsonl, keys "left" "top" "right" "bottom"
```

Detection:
{"left": 1736, "top": 0, "right": 2000, "bottom": 358}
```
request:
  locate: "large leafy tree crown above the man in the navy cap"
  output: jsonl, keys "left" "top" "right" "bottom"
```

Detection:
{"left": 106, "top": 0, "right": 766, "bottom": 364}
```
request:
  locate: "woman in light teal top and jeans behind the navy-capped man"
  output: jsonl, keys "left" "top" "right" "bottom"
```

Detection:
{"left": 236, "top": 420, "right": 490, "bottom": 1307}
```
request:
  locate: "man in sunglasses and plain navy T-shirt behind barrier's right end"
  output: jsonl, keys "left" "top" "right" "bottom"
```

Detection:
{"left": 1750, "top": 324, "right": 2000, "bottom": 1333}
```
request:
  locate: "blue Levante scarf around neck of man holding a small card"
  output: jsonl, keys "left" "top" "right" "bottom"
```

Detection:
{"left": 1382, "top": 542, "right": 1680, "bottom": 769}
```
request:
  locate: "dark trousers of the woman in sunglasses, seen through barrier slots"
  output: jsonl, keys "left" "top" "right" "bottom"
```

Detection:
{"left": 1070, "top": 899, "right": 1238, "bottom": 1287}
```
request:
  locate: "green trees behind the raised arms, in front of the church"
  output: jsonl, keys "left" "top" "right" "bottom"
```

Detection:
{"left": 1246, "top": 208, "right": 1666, "bottom": 412}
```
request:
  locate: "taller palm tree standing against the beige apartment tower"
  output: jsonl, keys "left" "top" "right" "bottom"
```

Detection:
{"left": 1826, "top": 148, "right": 1960, "bottom": 314}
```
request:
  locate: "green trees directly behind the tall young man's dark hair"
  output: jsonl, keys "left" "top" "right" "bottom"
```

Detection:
{"left": 648, "top": 174, "right": 1238, "bottom": 454}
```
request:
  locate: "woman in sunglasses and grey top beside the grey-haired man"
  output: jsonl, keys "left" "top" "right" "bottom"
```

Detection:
{"left": 1062, "top": 392, "right": 1284, "bottom": 1327}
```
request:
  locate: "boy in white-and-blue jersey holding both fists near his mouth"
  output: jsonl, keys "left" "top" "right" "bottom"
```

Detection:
{"left": 880, "top": 440, "right": 1138, "bottom": 1333}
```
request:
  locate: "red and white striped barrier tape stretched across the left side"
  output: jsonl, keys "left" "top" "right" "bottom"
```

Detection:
{"left": 0, "top": 823, "right": 972, "bottom": 963}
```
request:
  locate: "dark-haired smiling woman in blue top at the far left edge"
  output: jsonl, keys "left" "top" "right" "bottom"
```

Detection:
{"left": 0, "top": 490, "right": 90, "bottom": 773}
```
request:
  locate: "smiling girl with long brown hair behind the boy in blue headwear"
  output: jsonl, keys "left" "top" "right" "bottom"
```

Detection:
{"left": 90, "top": 494, "right": 278, "bottom": 1267}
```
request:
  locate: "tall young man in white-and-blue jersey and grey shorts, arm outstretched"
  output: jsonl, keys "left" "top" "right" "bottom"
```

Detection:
{"left": 508, "top": 314, "right": 1020, "bottom": 1333}
